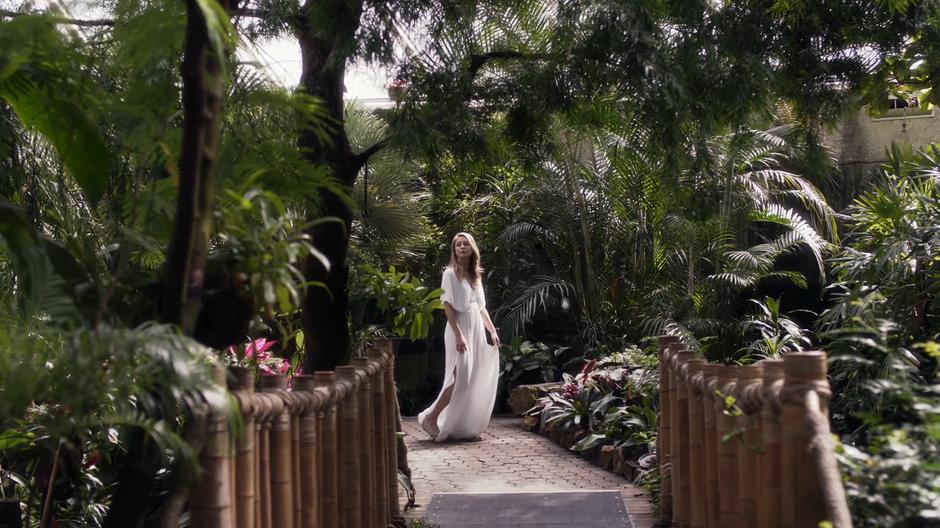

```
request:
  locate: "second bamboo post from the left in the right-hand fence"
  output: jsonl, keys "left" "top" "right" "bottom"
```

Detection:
{"left": 669, "top": 350, "right": 694, "bottom": 528}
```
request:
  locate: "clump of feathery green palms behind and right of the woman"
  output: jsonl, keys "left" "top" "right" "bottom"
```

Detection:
{"left": 485, "top": 119, "right": 834, "bottom": 360}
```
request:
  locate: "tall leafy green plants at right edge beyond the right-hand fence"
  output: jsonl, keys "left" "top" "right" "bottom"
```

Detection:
{"left": 818, "top": 142, "right": 940, "bottom": 526}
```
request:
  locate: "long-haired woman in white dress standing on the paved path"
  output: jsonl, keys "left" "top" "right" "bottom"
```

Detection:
{"left": 418, "top": 233, "right": 499, "bottom": 442}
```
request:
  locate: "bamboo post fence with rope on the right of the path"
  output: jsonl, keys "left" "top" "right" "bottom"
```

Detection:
{"left": 657, "top": 337, "right": 852, "bottom": 528}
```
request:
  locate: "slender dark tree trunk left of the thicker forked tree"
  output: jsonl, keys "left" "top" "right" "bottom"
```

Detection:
{"left": 105, "top": 0, "right": 228, "bottom": 528}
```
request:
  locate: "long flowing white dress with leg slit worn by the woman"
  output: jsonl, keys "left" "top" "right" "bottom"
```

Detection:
{"left": 418, "top": 267, "right": 499, "bottom": 442}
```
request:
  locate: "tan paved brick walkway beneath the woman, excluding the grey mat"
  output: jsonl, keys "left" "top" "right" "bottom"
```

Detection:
{"left": 404, "top": 416, "right": 656, "bottom": 528}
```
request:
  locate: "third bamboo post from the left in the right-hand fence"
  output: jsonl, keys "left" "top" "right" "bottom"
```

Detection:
{"left": 686, "top": 359, "right": 708, "bottom": 528}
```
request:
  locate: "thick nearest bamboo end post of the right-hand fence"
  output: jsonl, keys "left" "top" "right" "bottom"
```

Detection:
{"left": 780, "top": 352, "right": 829, "bottom": 527}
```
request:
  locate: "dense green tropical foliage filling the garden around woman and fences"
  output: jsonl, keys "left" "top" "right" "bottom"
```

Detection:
{"left": 0, "top": 0, "right": 940, "bottom": 526}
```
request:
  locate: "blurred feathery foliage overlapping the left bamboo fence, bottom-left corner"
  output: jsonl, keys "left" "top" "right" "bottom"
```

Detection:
{"left": 0, "top": 325, "right": 231, "bottom": 526}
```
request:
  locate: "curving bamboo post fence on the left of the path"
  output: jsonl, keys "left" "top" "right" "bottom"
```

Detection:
{"left": 189, "top": 342, "right": 400, "bottom": 528}
